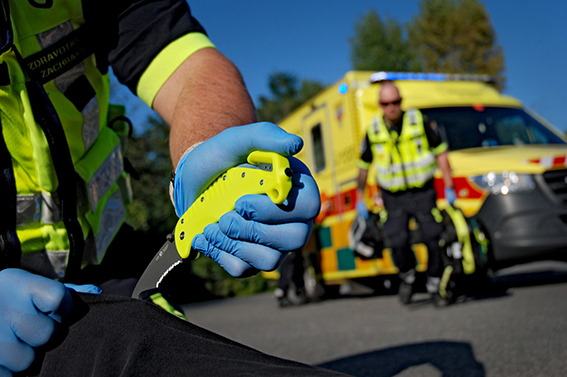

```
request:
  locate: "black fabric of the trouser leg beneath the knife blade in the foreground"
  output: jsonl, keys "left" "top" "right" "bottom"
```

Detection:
{"left": 22, "top": 294, "right": 350, "bottom": 377}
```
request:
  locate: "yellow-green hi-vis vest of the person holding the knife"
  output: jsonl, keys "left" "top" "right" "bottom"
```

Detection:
{"left": 0, "top": 0, "right": 212, "bottom": 280}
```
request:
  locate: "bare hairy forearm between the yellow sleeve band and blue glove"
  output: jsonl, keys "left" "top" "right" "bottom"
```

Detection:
{"left": 153, "top": 47, "right": 256, "bottom": 168}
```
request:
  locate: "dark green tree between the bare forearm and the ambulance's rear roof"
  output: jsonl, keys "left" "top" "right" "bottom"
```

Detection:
{"left": 257, "top": 72, "right": 324, "bottom": 123}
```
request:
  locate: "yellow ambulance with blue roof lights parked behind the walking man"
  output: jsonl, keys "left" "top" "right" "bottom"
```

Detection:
{"left": 268, "top": 71, "right": 567, "bottom": 292}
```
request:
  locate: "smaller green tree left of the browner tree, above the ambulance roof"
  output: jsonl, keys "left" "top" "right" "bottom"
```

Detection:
{"left": 349, "top": 9, "right": 420, "bottom": 72}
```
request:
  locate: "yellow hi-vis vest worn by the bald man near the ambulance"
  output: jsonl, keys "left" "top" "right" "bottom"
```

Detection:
{"left": 368, "top": 109, "right": 446, "bottom": 192}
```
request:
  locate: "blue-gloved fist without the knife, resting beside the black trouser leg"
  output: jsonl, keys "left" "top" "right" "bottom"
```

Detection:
{"left": 0, "top": 269, "right": 101, "bottom": 376}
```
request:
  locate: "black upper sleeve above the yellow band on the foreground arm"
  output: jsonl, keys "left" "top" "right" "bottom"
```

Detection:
{"left": 83, "top": 0, "right": 205, "bottom": 93}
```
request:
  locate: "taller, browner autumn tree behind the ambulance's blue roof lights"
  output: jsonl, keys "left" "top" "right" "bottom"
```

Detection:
{"left": 407, "top": 0, "right": 505, "bottom": 89}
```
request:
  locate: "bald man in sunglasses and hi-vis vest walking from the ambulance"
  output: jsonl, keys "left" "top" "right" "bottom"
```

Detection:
{"left": 356, "top": 81, "right": 456, "bottom": 304}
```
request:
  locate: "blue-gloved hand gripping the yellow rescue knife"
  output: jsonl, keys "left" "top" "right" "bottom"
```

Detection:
{"left": 174, "top": 122, "right": 321, "bottom": 277}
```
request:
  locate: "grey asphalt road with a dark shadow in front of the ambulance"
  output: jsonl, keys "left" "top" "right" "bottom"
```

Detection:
{"left": 184, "top": 262, "right": 567, "bottom": 376}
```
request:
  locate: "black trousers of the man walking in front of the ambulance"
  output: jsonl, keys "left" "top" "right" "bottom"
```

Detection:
{"left": 382, "top": 188, "right": 443, "bottom": 277}
